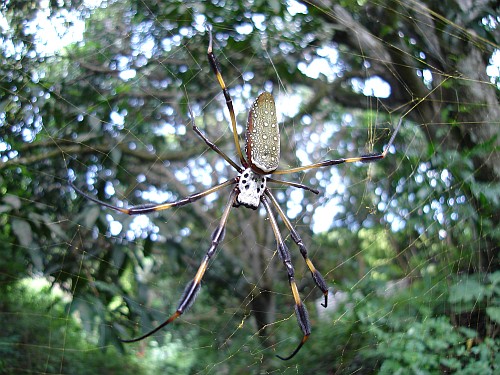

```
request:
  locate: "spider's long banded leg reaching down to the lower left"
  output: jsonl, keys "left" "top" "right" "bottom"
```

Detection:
{"left": 119, "top": 189, "right": 236, "bottom": 343}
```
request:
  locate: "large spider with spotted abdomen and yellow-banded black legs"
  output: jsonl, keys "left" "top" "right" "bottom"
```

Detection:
{"left": 70, "top": 25, "right": 402, "bottom": 360}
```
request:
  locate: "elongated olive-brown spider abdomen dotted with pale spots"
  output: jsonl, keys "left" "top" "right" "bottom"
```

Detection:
{"left": 245, "top": 92, "right": 280, "bottom": 174}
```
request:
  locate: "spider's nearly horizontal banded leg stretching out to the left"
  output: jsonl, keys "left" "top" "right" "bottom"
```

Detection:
{"left": 69, "top": 178, "right": 238, "bottom": 215}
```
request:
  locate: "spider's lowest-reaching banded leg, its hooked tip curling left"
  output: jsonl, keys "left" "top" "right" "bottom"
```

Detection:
{"left": 261, "top": 196, "right": 311, "bottom": 361}
